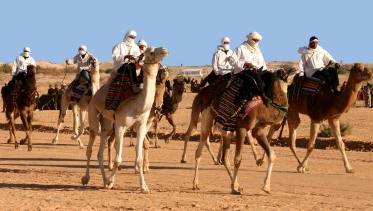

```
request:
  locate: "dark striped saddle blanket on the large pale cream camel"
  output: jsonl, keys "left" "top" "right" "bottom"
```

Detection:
{"left": 105, "top": 74, "right": 134, "bottom": 110}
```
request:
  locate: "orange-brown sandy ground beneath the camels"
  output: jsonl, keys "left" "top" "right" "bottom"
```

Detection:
{"left": 0, "top": 70, "right": 373, "bottom": 210}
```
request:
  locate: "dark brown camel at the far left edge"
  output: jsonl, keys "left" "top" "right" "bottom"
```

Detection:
{"left": 1, "top": 65, "right": 36, "bottom": 151}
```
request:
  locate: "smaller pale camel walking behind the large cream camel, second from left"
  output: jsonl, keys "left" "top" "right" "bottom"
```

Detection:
{"left": 52, "top": 59, "right": 100, "bottom": 149}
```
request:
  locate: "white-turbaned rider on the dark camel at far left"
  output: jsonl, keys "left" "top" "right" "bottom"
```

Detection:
{"left": 9, "top": 47, "right": 36, "bottom": 96}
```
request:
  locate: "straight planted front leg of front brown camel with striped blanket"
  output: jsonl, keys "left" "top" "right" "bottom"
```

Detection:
{"left": 231, "top": 128, "right": 246, "bottom": 194}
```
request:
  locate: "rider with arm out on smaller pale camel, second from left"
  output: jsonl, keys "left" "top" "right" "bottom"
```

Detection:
{"left": 66, "top": 45, "right": 97, "bottom": 85}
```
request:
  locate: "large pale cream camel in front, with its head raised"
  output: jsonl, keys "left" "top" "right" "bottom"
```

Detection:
{"left": 81, "top": 47, "right": 168, "bottom": 193}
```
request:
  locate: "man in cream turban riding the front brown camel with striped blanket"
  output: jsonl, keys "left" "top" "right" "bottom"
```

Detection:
{"left": 229, "top": 32, "right": 271, "bottom": 107}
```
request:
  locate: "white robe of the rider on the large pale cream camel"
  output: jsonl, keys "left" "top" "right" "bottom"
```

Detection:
{"left": 112, "top": 42, "right": 141, "bottom": 71}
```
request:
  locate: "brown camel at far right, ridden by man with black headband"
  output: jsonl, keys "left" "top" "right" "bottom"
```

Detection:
{"left": 287, "top": 63, "right": 373, "bottom": 173}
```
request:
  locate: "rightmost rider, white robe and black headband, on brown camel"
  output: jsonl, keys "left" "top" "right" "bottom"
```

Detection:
{"left": 298, "top": 36, "right": 340, "bottom": 94}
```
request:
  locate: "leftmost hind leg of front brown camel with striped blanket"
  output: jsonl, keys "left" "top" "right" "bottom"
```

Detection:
{"left": 193, "top": 109, "right": 214, "bottom": 190}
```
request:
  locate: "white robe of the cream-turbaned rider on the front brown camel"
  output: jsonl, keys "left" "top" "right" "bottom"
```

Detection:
{"left": 230, "top": 44, "right": 267, "bottom": 74}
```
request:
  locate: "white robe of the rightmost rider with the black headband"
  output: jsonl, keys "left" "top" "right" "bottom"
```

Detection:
{"left": 298, "top": 46, "right": 336, "bottom": 77}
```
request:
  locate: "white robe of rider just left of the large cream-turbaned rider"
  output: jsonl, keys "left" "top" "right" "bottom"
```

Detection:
{"left": 212, "top": 48, "right": 233, "bottom": 75}
